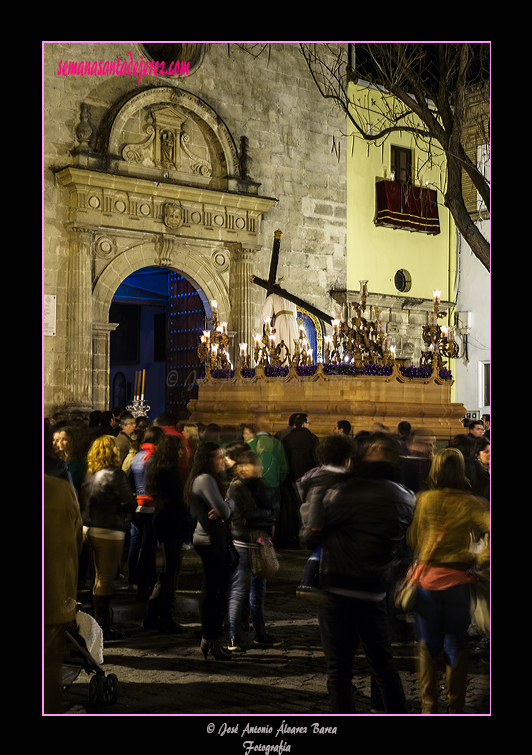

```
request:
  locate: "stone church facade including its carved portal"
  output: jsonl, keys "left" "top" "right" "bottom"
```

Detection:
{"left": 43, "top": 42, "right": 346, "bottom": 415}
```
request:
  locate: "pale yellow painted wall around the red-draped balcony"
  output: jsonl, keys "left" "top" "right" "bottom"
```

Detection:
{"left": 347, "top": 84, "right": 456, "bottom": 301}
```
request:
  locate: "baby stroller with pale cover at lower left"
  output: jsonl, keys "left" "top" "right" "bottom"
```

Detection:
{"left": 62, "top": 603, "right": 118, "bottom": 706}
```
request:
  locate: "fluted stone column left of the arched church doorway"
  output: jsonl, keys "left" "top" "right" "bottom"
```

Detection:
{"left": 65, "top": 228, "right": 93, "bottom": 415}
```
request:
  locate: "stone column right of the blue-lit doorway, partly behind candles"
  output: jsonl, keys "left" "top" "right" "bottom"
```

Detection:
{"left": 227, "top": 243, "right": 258, "bottom": 358}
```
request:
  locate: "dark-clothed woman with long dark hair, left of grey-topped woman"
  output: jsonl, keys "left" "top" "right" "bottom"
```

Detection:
{"left": 144, "top": 434, "right": 187, "bottom": 634}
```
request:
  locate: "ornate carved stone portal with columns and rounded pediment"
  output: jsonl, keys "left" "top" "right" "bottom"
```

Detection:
{"left": 56, "top": 87, "right": 276, "bottom": 411}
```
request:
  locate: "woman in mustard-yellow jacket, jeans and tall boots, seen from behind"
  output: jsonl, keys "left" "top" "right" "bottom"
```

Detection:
{"left": 407, "top": 448, "right": 490, "bottom": 713}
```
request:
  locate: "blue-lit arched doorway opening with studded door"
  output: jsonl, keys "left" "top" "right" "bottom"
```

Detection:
{"left": 109, "top": 266, "right": 206, "bottom": 422}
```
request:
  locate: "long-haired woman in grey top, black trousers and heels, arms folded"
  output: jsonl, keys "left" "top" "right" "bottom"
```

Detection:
{"left": 185, "top": 441, "right": 231, "bottom": 660}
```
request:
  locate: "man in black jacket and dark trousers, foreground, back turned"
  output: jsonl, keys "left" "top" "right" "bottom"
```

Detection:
{"left": 302, "top": 438, "right": 415, "bottom": 713}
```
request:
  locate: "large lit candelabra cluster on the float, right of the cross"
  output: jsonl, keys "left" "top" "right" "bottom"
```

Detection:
{"left": 325, "top": 281, "right": 395, "bottom": 370}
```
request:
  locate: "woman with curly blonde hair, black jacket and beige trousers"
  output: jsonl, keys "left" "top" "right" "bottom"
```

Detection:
{"left": 82, "top": 435, "right": 137, "bottom": 640}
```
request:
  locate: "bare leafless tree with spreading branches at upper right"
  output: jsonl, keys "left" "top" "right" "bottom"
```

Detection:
{"left": 300, "top": 43, "right": 490, "bottom": 270}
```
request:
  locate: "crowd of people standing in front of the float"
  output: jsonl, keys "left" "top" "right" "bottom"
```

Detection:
{"left": 44, "top": 411, "right": 490, "bottom": 713}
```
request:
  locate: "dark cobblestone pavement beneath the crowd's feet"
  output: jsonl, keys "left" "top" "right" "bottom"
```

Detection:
{"left": 64, "top": 550, "right": 490, "bottom": 728}
